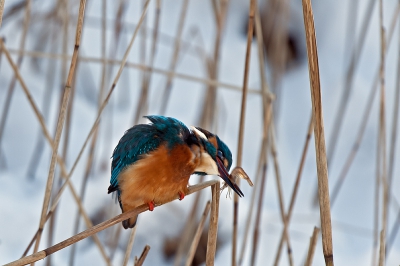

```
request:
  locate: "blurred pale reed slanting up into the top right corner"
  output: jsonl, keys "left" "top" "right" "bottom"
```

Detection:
{"left": 320, "top": 0, "right": 400, "bottom": 206}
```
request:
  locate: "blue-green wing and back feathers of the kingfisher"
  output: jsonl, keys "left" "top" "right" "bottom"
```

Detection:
{"left": 108, "top": 116, "right": 190, "bottom": 193}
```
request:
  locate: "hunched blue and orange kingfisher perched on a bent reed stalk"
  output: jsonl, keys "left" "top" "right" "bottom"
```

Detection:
{"left": 108, "top": 115, "right": 244, "bottom": 229}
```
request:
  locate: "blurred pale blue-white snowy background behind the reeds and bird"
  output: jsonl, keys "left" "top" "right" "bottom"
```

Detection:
{"left": 0, "top": 0, "right": 400, "bottom": 265}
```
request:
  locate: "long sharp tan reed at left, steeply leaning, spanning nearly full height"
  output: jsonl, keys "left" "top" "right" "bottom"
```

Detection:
{"left": 32, "top": 0, "right": 86, "bottom": 260}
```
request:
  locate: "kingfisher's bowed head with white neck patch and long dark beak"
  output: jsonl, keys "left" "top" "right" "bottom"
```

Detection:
{"left": 191, "top": 127, "right": 244, "bottom": 197}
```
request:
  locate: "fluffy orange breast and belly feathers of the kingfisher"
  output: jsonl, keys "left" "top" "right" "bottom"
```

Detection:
{"left": 118, "top": 144, "right": 200, "bottom": 212}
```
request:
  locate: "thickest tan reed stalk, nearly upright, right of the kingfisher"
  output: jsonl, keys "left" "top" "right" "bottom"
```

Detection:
{"left": 302, "top": 0, "right": 334, "bottom": 266}
